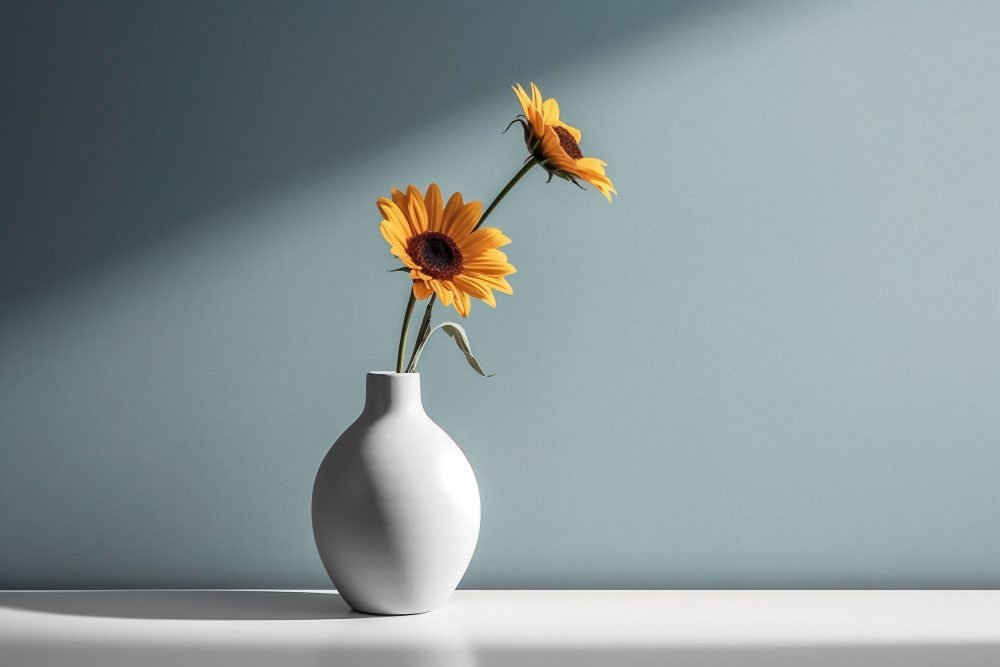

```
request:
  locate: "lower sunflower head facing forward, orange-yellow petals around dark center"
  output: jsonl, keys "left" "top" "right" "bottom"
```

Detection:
{"left": 378, "top": 183, "right": 516, "bottom": 317}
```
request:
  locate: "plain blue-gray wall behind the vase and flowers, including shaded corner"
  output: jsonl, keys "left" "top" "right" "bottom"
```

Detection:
{"left": 0, "top": 0, "right": 1000, "bottom": 587}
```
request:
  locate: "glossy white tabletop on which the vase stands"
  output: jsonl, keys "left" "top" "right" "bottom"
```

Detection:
{"left": 0, "top": 590, "right": 1000, "bottom": 667}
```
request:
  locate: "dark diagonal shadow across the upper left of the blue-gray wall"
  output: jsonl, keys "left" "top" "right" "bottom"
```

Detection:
{"left": 0, "top": 0, "right": 715, "bottom": 318}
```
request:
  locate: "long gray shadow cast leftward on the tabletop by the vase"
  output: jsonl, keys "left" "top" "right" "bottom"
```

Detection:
{"left": 0, "top": 590, "right": 372, "bottom": 621}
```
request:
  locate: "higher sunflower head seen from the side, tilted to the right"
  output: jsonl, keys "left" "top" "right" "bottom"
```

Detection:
{"left": 512, "top": 83, "right": 618, "bottom": 201}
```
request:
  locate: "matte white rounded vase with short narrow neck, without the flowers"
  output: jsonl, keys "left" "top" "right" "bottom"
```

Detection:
{"left": 312, "top": 372, "right": 480, "bottom": 614}
